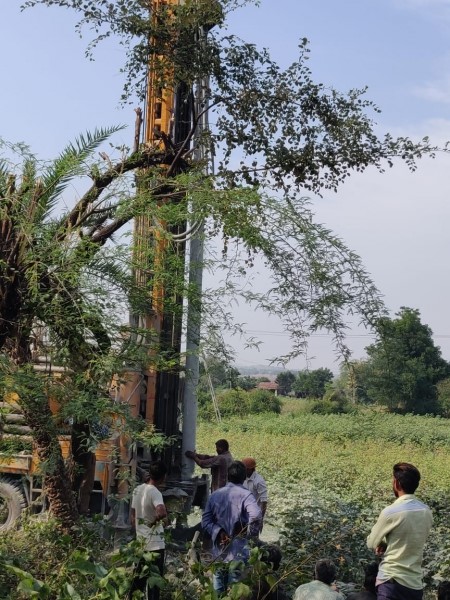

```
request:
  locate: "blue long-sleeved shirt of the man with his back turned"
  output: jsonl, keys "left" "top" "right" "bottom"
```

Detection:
{"left": 202, "top": 483, "right": 261, "bottom": 562}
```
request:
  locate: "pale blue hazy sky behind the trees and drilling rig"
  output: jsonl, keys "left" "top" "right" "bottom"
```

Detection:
{"left": 0, "top": 0, "right": 450, "bottom": 371}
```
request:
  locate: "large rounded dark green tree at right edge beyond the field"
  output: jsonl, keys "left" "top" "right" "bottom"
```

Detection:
{"left": 366, "top": 307, "right": 450, "bottom": 414}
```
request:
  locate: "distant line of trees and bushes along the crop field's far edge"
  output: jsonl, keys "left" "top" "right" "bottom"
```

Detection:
{"left": 199, "top": 307, "right": 450, "bottom": 417}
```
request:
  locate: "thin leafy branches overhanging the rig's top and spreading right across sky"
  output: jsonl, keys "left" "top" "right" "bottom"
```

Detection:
{"left": 24, "top": 0, "right": 440, "bottom": 359}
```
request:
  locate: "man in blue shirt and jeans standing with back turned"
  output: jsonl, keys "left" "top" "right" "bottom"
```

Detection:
{"left": 202, "top": 460, "right": 262, "bottom": 593}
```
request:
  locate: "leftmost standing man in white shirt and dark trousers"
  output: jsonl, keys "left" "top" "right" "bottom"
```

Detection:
{"left": 130, "top": 461, "right": 167, "bottom": 600}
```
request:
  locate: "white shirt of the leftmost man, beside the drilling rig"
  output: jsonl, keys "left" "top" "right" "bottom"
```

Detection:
{"left": 131, "top": 483, "right": 165, "bottom": 550}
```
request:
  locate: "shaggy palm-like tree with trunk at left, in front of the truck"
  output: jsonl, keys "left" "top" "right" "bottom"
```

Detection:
{"left": 0, "top": 128, "right": 192, "bottom": 528}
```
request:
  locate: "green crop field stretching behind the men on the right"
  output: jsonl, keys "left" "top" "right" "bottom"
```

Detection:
{"left": 197, "top": 408, "right": 450, "bottom": 589}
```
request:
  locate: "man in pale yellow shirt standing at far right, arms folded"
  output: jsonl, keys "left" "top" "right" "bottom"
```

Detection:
{"left": 367, "top": 462, "right": 433, "bottom": 600}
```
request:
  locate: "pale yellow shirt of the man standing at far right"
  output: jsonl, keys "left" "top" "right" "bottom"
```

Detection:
{"left": 367, "top": 494, "right": 433, "bottom": 590}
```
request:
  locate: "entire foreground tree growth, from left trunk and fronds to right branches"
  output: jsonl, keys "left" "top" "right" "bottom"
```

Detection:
{"left": 0, "top": 0, "right": 442, "bottom": 526}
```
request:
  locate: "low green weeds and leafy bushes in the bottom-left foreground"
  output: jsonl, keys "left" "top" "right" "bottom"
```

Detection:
{"left": 0, "top": 518, "right": 165, "bottom": 600}
